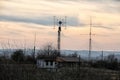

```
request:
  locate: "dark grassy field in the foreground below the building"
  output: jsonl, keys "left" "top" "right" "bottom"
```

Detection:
{"left": 0, "top": 64, "right": 119, "bottom": 80}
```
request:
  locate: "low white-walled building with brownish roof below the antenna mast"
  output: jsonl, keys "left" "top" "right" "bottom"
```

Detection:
{"left": 37, "top": 56, "right": 80, "bottom": 69}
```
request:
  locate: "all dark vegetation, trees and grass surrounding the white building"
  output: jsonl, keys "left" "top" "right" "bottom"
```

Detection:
{"left": 0, "top": 45, "right": 120, "bottom": 80}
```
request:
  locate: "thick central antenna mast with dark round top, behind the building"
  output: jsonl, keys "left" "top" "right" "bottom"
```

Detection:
{"left": 54, "top": 16, "right": 67, "bottom": 56}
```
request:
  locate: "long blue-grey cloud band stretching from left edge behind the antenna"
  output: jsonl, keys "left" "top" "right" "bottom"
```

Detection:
{"left": 0, "top": 15, "right": 78, "bottom": 26}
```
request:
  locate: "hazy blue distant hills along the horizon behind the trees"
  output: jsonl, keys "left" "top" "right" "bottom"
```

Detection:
{"left": 0, "top": 49, "right": 120, "bottom": 60}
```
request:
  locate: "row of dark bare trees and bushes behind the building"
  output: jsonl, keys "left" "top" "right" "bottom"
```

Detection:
{"left": 0, "top": 45, "right": 120, "bottom": 70}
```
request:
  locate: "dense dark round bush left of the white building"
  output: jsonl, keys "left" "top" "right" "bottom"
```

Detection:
{"left": 11, "top": 50, "right": 25, "bottom": 63}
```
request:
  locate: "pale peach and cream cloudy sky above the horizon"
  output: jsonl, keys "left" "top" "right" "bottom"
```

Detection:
{"left": 0, "top": 0, "right": 120, "bottom": 51}
